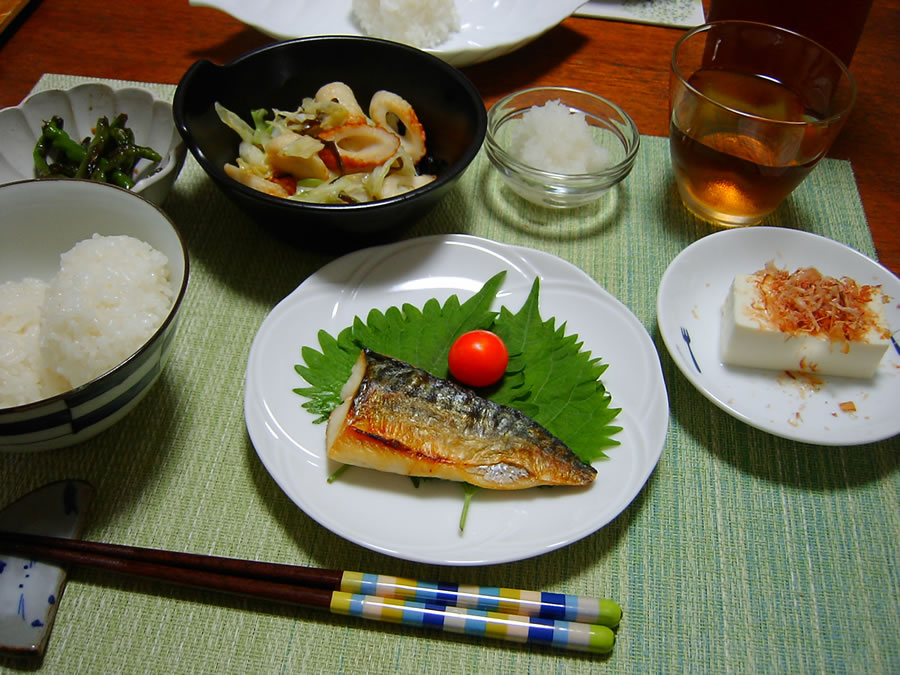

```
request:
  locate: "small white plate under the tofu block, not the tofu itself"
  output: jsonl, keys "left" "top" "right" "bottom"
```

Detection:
{"left": 657, "top": 227, "right": 900, "bottom": 446}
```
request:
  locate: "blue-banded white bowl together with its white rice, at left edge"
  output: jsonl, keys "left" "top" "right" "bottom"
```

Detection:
{"left": 0, "top": 179, "right": 188, "bottom": 452}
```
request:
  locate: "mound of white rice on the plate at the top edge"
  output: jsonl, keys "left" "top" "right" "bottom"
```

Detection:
{"left": 353, "top": 0, "right": 460, "bottom": 47}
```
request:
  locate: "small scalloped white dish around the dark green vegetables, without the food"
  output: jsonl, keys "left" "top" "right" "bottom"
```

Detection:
{"left": 0, "top": 83, "right": 187, "bottom": 205}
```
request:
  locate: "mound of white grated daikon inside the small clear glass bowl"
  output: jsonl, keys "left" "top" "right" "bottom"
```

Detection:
{"left": 509, "top": 100, "right": 609, "bottom": 174}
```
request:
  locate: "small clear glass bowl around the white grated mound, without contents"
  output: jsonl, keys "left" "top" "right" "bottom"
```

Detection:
{"left": 485, "top": 87, "right": 641, "bottom": 208}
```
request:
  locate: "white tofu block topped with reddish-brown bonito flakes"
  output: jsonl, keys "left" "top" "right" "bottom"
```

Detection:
{"left": 721, "top": 263, "right": 890, "bottom": 378}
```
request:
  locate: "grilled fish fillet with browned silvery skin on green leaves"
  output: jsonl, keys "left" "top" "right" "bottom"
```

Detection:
{"left": 325, "top": 349, "right": 597, "bottom": 490}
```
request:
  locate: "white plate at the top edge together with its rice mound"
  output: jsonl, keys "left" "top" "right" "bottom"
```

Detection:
{"left": 190, "top": 0, "right": 584, "bottom": 67}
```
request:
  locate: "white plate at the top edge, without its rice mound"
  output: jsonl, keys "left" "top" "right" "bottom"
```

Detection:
{"left": 190, "top": 0, "right": 584, "bottom": 67}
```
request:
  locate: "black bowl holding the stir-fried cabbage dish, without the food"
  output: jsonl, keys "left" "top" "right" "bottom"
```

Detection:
{"left": 173, "top": 36, "right": 487, "bottom": 244}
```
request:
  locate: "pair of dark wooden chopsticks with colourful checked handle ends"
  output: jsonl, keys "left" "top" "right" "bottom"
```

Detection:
{"left": 0, "top": 532, "right": 622, "bottom": 653}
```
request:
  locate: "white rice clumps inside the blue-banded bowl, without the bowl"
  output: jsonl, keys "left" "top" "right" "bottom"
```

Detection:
{"left": 0, "top": 234, "right": 174, "bottom": 407}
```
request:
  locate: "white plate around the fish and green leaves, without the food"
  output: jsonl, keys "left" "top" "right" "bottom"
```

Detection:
{"left": 244, "top": 235, "right": 669, "bottom": 565}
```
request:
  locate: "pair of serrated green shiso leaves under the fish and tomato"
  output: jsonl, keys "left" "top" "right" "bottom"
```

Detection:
{"left": 293, "top": 272, "right": 621, "bottom": 462}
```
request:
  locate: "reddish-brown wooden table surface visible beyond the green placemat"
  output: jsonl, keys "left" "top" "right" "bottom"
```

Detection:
{"left": 0, "top": 0, "right": 900, "bottom": 274}
